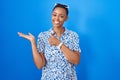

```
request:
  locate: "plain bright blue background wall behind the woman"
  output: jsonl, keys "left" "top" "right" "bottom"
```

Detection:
{"left": 0, "top": 0, "right": 120, "bottom": 80}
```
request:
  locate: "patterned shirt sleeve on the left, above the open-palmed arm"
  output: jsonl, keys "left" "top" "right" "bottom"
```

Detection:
{"left": 37, "top": 32, "right": 45, "bottom": 53}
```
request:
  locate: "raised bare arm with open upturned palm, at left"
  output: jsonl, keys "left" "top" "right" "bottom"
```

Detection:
{"left": 18, "top": 32, "right": 46, "bottom": 69}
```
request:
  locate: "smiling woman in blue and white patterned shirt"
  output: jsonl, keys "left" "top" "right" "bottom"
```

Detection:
{"left": 18, "top": 4, "right": 81, "bottom": 80}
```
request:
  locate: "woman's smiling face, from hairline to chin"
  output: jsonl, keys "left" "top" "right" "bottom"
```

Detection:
{"left": 52, "top": 7, "right": 68, "bottom": 28}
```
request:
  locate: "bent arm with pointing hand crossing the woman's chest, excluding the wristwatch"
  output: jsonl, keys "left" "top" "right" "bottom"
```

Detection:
{"left": 48, "top": 35, "right": 80, "bottom": 65}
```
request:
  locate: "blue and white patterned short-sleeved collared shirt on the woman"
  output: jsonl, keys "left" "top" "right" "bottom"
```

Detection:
{"left": 37, "top": 28, "right": 81, "bottom": 80}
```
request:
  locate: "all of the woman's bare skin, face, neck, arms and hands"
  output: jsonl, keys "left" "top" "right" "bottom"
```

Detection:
{"left": 18, "top": 7, "right": 80, "bottom": 69}
